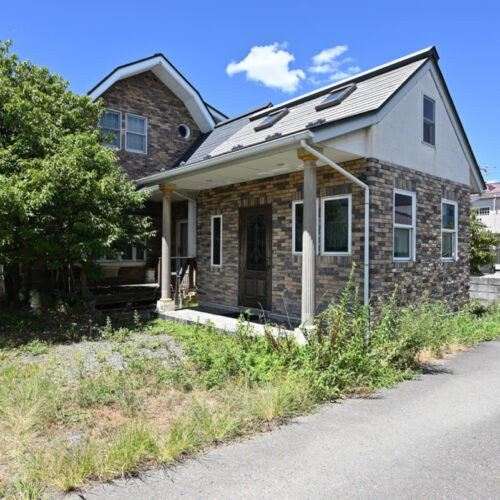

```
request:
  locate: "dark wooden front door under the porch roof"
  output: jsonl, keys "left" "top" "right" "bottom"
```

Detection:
{"left": 239, "top": 206, "right": 272, "bottom": 310}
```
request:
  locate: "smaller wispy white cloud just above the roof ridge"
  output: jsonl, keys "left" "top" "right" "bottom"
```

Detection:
{"left": 309, "top": 45, "right": 361, "bottom": 85}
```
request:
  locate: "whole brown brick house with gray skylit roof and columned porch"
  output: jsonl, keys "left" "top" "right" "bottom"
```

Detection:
{"left": 90, "top": 47, "right": 485, "bottom": 325}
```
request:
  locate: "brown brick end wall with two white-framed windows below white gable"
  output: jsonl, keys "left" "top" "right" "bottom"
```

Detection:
{"left": 366, "top": 159, "right": 470, "bottom": 308}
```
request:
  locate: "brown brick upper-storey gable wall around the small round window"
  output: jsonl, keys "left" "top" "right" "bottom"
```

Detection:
{"left": 102, "top": 71, "right": 201, "bottom": 179}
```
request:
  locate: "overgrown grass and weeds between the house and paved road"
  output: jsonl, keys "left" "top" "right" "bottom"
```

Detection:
{"left": 0, "top": 283, "right": 500, "bottom": 498}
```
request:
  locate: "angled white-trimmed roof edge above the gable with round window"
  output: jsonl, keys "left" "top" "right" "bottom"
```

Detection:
{"left": 88, "top": 54, "right": 227, "bottom": 133}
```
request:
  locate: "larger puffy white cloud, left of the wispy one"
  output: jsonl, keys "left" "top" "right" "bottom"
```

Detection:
{"left": 226, "top": 43, "right": 306, "bottom": 92}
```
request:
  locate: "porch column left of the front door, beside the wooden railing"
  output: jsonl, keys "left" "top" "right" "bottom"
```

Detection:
{"left": 156, "top": 184, "right": 175, "bottom": 312}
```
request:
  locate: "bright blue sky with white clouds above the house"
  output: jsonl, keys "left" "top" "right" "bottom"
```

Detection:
{"left": 0, "top": 0, "right": 500, "bottom": 180}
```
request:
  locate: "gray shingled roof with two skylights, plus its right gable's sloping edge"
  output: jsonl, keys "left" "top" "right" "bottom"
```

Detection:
{"left": 175, "top": 47, "right": 485, "bottom": 189}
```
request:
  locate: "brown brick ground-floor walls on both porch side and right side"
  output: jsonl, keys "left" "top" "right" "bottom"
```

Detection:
{"left": 197, "top": 159, "right": 469, "bottom": 317}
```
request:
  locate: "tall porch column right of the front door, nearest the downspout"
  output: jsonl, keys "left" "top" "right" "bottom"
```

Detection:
{"left": 298, "top": 149, "right": 317, "bottom": 328}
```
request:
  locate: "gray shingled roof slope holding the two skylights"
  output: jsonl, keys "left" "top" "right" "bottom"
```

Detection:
{"left": 185, "top": 56, "right": 431, "bottom": 164}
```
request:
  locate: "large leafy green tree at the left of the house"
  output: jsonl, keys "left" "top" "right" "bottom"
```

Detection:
{"left": 0, "top": 41, "right": 150, "bottom": 300}
